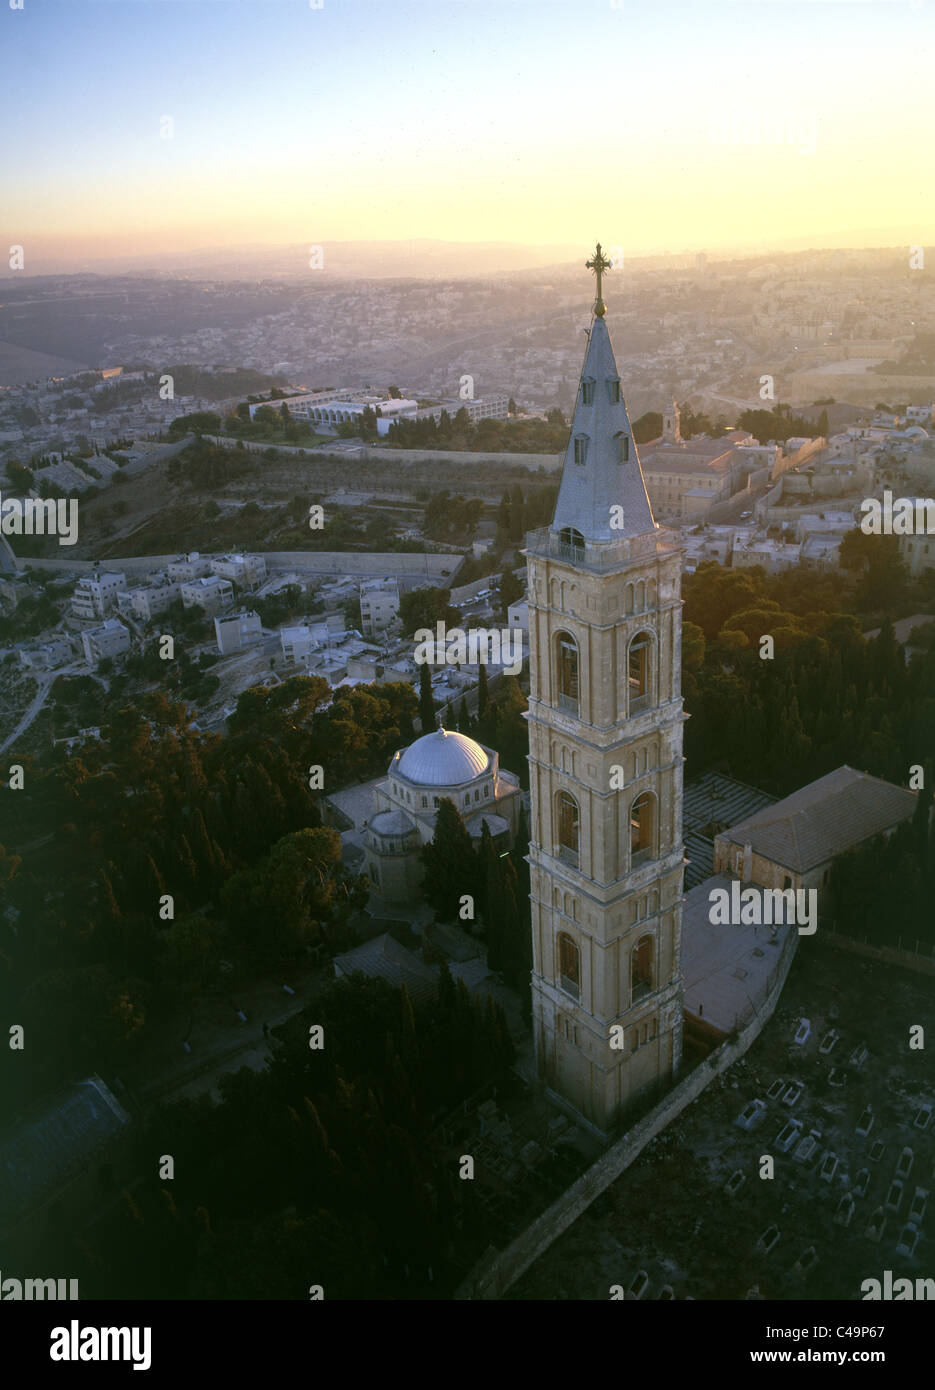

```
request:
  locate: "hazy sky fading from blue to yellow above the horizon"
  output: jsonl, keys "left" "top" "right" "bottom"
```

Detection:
{"left": 0, "top": 0, "right": 935, "bottom": 268}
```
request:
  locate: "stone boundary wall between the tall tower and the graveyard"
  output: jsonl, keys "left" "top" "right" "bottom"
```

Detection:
{"left": 454, "top": 933, "right": 799, "bottom": 1300}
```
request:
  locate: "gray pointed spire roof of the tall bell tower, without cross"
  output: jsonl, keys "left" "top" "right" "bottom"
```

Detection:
{"left": 552, "top": 309, "right": 657, "bottom": 541}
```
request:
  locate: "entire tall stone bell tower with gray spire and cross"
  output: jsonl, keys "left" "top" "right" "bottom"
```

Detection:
{"left": 527, "top": 245, "right": 684, "bottom": 1133}
